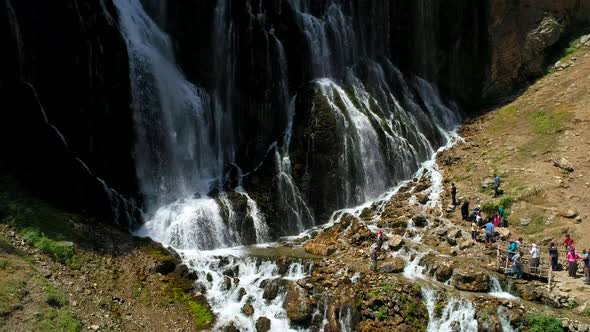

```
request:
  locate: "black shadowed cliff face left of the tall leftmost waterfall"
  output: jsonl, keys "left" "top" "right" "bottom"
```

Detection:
{"left": 0, "top": 0, "right": 137, "bottom": 225}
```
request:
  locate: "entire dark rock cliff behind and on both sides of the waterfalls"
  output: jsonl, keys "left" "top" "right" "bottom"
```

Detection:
{"left": 0, "top": 0, "right": 590, "bottom": 225}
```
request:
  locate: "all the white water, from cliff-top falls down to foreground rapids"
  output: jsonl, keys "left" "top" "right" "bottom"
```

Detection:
{"left": 114, "top": 0, "right": 477, "bottom": 331}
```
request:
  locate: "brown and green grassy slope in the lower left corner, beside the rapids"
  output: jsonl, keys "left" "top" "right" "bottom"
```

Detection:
{"left": 0, "top": 173, "right": 214, "bottom": 331}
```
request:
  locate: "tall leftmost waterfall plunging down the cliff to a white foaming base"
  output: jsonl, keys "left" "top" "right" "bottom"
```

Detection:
{"left": 114, "top": 0, "right": 268, "bottom": 249}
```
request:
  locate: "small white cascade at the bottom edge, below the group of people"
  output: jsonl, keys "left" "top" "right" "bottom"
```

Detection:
{"left": 422, "top": 288, "right": 477, "bottom": 332}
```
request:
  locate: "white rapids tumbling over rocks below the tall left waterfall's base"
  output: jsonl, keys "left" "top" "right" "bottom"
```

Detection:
{"left": 181, "top": 249, "right": 309, "bottom": 331}
